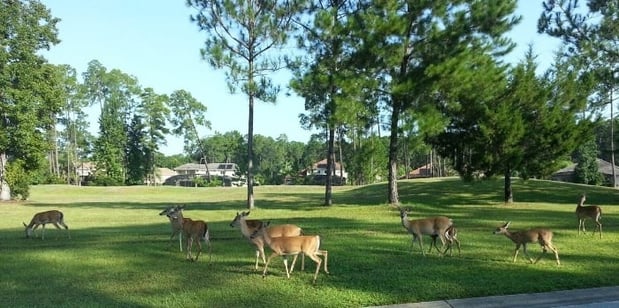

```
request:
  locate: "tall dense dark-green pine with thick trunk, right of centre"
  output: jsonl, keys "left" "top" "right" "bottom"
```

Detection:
{"left": 352, "top": 0, "right": 519, "bottom": 204}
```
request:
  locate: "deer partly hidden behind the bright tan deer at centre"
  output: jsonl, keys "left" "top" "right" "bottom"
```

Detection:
{"left": 230, "top": 211, "right": 305, "bottom": 270}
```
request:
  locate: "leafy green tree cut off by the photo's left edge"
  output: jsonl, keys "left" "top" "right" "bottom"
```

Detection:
{"left": 0, "top": 0, "right": 59, "bottom": 200}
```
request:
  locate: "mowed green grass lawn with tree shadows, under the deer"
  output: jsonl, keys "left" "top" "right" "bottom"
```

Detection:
{"left": 0, "top": 178, "right": 619, "bottom": 307}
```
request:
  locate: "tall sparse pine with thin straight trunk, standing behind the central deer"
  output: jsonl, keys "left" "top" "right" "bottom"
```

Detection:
{"left": 187, "top": 0, "right": 306, "bottom": 209}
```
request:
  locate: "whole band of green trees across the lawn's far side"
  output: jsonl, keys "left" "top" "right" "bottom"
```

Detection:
{"left": 0, "top": 0, "right": 619, "bottom": 208}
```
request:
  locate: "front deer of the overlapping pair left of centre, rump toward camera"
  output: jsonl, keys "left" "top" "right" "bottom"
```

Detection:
{"left": 167, "top": 206, "right": 212, "bottom": 262}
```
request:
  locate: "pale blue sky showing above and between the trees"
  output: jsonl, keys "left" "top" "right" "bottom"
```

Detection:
{"left": 41, "top": 0, "right": 558, "bottom": 155}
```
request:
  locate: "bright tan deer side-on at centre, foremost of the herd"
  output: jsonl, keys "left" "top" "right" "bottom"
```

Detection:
{"left": 250, "top": 222, "right": 329, "bottom": 283}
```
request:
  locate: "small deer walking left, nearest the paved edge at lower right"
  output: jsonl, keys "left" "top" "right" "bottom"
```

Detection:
{"left": 493, "top": 221, "right": 561, "bottom": 265}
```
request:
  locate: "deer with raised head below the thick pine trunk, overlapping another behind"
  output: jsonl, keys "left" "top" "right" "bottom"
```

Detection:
{"left": 399, "top": 208, "right": 453, "bottom": 256}
